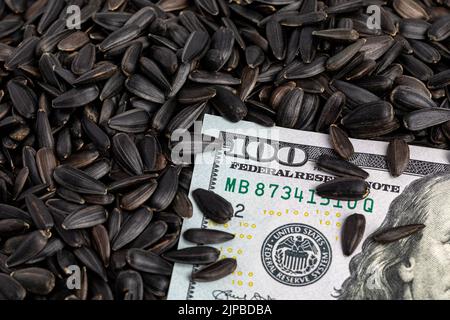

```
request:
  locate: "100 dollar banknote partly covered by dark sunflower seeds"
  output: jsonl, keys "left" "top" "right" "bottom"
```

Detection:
{"left": 168, "top": 115, "right": 450, "bottom": 300}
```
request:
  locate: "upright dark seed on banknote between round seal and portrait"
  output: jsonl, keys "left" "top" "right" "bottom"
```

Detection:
{"left": 342, "top": 213, "right": 366, "bottom": 256}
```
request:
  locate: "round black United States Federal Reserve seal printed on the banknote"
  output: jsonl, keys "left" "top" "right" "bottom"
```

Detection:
{"left": 261, "top": 223, "right": 332, "bottom": 287}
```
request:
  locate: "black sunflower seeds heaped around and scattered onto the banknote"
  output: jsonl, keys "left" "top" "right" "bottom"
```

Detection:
{"left": 0, "top": 0, "right": 450, "bottom": 300}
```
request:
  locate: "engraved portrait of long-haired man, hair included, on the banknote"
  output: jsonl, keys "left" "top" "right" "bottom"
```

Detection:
{"left": 338, "top": 173, "right": 450, "bottom": 300}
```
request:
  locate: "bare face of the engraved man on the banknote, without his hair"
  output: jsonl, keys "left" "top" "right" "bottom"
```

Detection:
{"left": 399, "top": 192, "right": 450, "bottom": 300}
